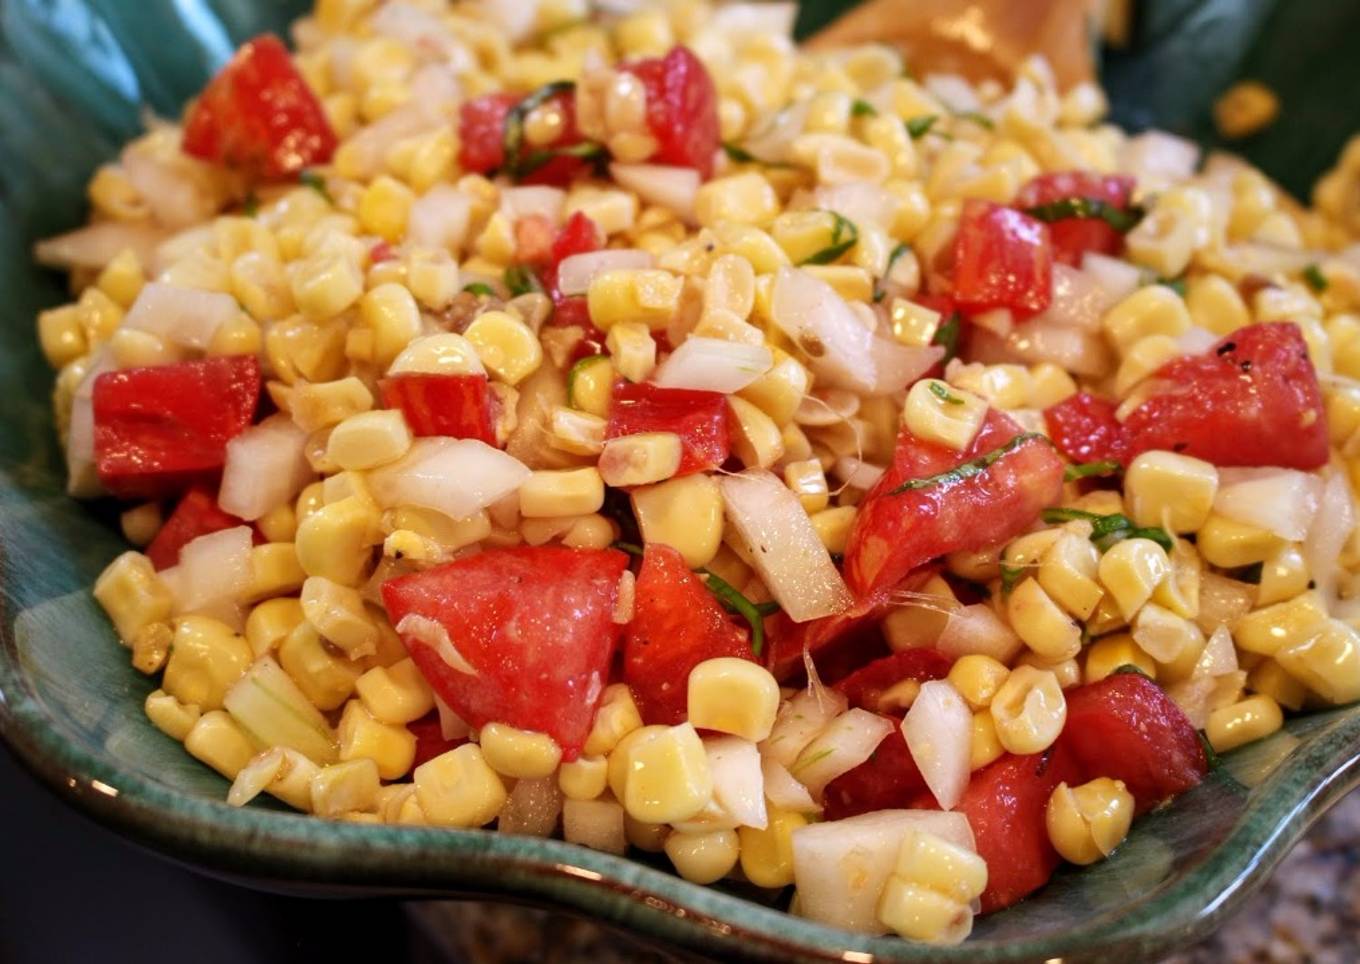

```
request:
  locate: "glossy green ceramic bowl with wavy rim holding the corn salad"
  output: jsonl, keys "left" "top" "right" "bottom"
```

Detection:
{"left": 0, "top": 0, "right": 1360, "bottom": 961}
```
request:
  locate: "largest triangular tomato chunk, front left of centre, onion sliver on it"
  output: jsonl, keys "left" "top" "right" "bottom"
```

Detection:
{"left": 382, "top": 547, "right": 628, "bottom": 760}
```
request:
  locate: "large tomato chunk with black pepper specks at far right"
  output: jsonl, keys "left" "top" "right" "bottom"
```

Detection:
{"left": 1123, "top": 321, "right": 1327, "bottom": 469}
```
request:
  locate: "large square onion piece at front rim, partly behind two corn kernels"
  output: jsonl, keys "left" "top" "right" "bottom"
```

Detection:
{"left": 793, "top": 810, "right": 976, "bottom": 934}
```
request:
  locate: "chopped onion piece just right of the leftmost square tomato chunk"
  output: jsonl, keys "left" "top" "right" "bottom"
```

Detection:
{"left": 218, "top": 413, "right": 313, "bottom": 522}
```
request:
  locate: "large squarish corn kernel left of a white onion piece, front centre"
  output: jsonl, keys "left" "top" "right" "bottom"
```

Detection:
{"left": 623, "top": 723, "right": 713, "bottom": 824}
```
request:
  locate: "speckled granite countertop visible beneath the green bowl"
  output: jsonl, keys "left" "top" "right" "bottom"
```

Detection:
{"left": 408, "top": 791, "right": 1360, "bottom": 964}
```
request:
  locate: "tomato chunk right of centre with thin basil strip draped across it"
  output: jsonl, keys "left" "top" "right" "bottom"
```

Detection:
{"left": 845, "top": 409, "right": 1062, "bottom": 598}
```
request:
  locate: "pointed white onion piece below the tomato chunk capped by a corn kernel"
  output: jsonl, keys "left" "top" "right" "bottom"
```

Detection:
{"left": 369, "top": 438, "right": 530, "bottom": 519}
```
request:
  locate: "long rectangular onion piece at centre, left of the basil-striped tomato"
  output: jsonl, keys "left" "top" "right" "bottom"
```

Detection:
{"left": 723, "top": 469, "right": 854, "bottom": 623}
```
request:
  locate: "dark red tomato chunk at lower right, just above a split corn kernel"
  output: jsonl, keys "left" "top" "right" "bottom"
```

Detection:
{"left": 1058, "top": 673, "right": 1209, "bottom": 813}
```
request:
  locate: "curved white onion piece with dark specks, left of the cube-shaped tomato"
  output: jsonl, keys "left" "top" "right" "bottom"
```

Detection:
{"left": 771, "top": 268, "right": 944, "bottom": 394}
